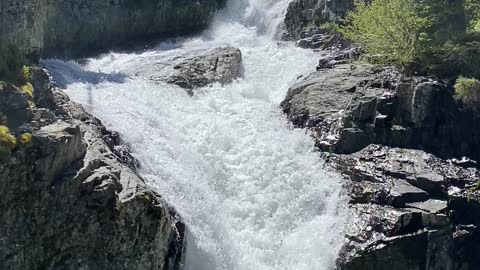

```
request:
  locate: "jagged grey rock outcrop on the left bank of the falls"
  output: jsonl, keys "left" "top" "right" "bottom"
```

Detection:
{"left": 0, "top": 68, "right": 184, "bottom": 270}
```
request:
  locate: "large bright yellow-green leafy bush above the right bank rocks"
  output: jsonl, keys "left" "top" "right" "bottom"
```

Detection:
{"left": 339, "top": 0, "right": 431, "bottom": 66}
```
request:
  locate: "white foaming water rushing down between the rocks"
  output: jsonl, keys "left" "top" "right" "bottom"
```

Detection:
{"left": 44, "top": 0, "right": 348, "bottom": 270}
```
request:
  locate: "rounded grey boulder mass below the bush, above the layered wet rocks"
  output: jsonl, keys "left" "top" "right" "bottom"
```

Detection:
{"left": 281, "top": 64, "right": 480, "bottom": 161}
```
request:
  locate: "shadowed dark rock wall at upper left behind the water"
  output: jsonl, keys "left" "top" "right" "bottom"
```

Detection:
{"left": 0, "top": 0, "right": 224, "bottom": 75}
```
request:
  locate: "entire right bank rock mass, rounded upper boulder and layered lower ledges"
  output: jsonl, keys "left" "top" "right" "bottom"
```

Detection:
{"left": 281, "top": 61, "right": 480, "bottom": 270}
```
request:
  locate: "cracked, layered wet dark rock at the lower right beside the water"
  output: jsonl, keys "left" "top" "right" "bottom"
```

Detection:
{"left": 323, "top": 145, "right": 480, "bottom": 270}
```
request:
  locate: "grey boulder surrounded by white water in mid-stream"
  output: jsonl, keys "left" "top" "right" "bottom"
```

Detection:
{"left": 166, "top": 47, "right": 243, "bottom": 93}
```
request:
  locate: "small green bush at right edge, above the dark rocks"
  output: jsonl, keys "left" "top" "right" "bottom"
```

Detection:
{"left": 454, "top": 77, "right": 480, "bottom": 111}
